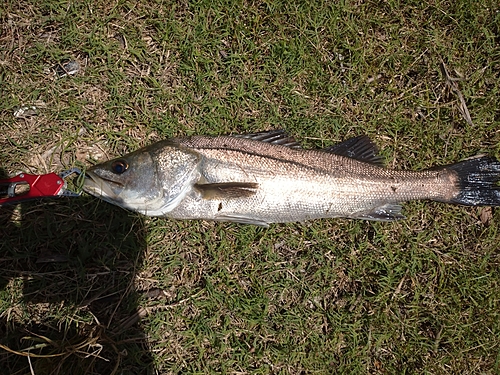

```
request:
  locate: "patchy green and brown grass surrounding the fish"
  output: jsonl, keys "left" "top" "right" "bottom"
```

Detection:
{"left": 0, "top": 0, "right": 500, "bottom": 375}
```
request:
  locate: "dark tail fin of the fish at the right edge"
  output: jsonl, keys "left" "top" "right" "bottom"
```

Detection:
{"left": 446, "top": 157, "right": 500, "bottom": 206}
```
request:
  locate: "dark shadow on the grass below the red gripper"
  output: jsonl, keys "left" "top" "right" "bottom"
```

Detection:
{"left": 0, "top": 169, "right": 154, "bottom": 375}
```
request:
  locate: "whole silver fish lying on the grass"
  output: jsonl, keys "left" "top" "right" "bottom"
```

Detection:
{"left": 83, "top": 130, "right": 500, "bottom": 227}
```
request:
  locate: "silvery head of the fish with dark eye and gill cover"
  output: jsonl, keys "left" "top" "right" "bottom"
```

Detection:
{"left": 83, "top": 141, "right": 199, "bottom": 216}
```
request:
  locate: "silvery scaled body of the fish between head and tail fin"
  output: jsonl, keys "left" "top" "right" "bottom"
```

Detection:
{"left": 169, "top": 137, "right": 456, "bottom": 223}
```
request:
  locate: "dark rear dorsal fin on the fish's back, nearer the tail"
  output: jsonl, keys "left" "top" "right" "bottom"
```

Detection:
{"left": 323, "top": 135, "right": 384, "bottom": 166}
